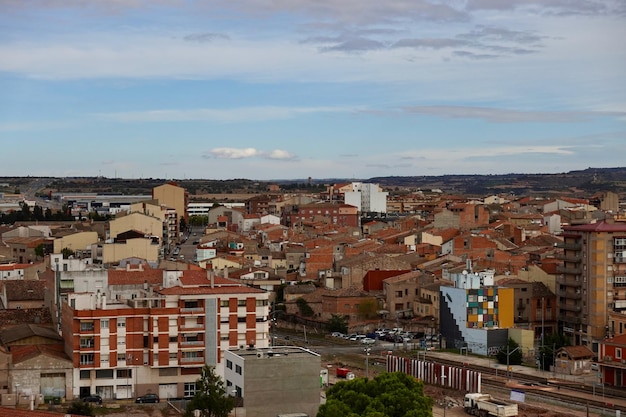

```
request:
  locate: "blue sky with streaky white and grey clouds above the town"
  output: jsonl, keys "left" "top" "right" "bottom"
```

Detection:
{"left": 0, "top": 0, "right": 626, "bottom": 180}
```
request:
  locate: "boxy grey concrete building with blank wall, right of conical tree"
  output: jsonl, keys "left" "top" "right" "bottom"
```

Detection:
{"left": 224, "top": 346, "right": 321, "bottom": 417}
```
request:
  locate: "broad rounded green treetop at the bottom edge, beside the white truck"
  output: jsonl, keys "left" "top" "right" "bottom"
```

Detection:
{"left": 317, "top": 372, "right": 433, "bottom": 417}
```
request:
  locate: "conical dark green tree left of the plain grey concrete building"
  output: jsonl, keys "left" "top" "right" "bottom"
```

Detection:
{"left": 183, "top": 365, "right": 235, "bottom": 417}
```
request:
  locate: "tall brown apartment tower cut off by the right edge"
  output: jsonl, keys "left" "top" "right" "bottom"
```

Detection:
{"left": 557, "top": 222, "right": 626, "bottom": 353}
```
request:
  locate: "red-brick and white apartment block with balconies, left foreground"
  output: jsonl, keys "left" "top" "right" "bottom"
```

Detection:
{"left": 62, "top": 270, "right": 269, "bottom": 399}
